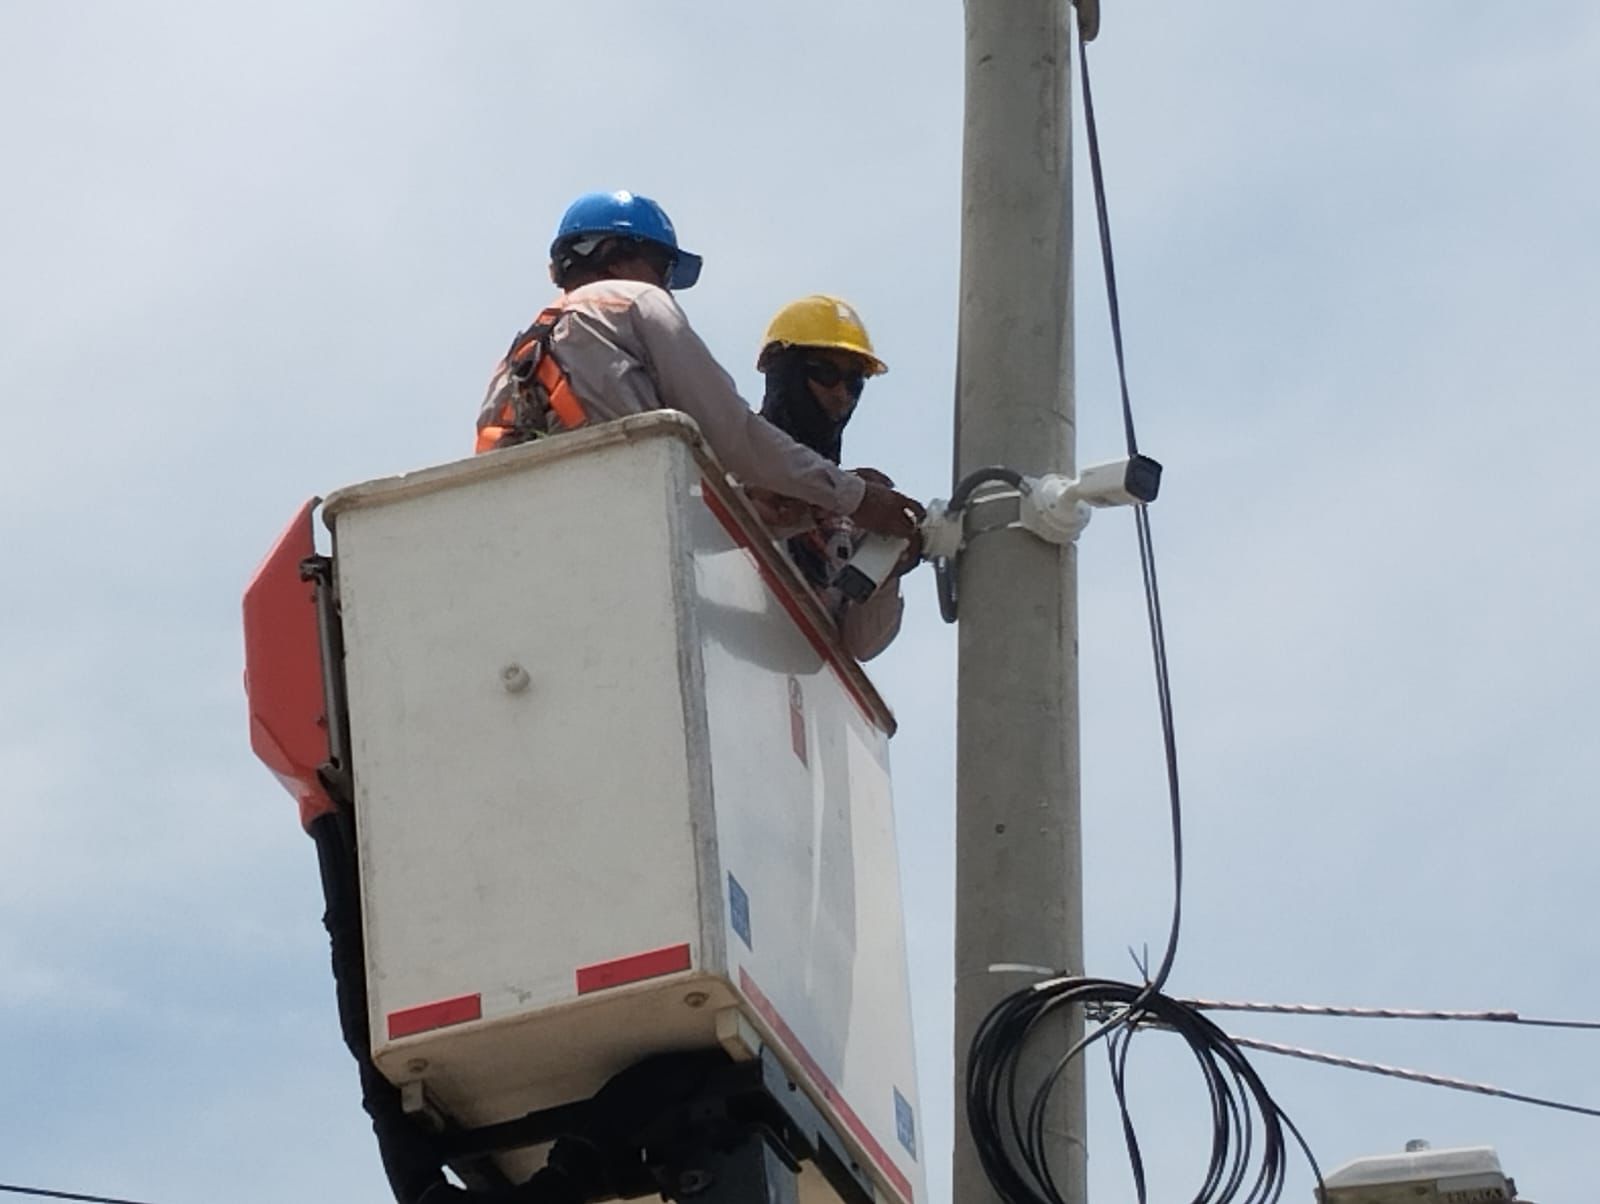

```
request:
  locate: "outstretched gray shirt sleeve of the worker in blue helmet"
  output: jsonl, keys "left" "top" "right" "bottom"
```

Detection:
{"left": 634, "top": 288, "right": 867, "bottom": 514}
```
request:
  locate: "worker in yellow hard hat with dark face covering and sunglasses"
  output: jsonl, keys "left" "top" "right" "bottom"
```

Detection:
{"left": 754, "top": 293, "right": 917, "bottom": 660}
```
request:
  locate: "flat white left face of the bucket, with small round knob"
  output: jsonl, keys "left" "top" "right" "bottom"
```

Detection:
{"left": 330, "top": 429, "right": 701, "bottom": 1095}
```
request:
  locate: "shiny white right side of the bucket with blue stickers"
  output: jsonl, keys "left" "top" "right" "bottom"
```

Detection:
{"left": 690, "top": 483, "right": 925, "bottom": 1199}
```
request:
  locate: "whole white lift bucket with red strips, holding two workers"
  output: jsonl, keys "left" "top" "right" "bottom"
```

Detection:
{"left": 325, "top": 413, "right": 925, "bottom": 1202}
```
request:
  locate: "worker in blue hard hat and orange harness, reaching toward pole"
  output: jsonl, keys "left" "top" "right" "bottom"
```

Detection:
{"left": 477, "top": 192, "right": 922, "bottom": 540}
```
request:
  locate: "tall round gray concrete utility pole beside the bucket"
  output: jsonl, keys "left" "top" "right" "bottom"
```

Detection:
{"left": 954, "top": 0, "right": 1086, "bottom": 1204}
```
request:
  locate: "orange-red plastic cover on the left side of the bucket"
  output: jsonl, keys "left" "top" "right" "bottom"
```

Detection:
{"left": 245, "top": 498, "right": 334, "bottom": 828}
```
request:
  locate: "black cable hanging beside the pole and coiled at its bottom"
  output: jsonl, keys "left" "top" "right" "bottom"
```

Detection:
{"left": 960, "top": 21, "right": 1323, "bottom": 1204}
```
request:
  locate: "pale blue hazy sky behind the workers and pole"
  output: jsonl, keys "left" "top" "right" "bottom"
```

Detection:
{"left": 0, "top": 0, "right": 1600, "bottom": 1204}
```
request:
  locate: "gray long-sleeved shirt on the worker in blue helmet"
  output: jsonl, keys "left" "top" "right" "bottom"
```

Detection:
{"left": 502, "top": 280, "right": 866, "bottom": 514}
